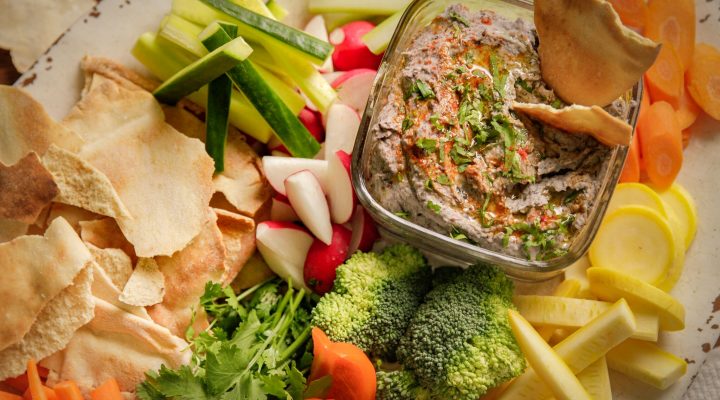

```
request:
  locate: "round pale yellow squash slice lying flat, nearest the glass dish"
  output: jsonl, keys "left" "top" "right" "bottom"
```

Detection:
{"left": 589, "top": 206, "right": 676, "bottom": 285}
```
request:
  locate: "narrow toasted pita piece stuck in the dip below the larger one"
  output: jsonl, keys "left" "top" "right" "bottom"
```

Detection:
{"left": 512, "top": 102, "right": 632, "bottom": 146}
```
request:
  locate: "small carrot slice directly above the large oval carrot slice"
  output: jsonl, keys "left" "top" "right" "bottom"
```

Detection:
{"left": 645, "top": 44, "right": 683, "bottom": 108}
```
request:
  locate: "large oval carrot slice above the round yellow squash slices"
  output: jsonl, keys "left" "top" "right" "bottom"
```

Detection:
{"left": 638, "top": 101, "right": 683, "bottom": 190}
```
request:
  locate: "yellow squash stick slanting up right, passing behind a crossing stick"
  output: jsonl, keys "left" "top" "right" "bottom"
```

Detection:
{"left": 500, "top": 300, "right": 636, "bottom": 400}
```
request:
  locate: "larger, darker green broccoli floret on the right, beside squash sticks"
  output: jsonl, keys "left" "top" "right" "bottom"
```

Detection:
{"left": 397, "top": 265, "right": 526, "bottom": 399}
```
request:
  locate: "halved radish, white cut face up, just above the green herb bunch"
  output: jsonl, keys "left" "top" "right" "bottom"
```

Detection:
{"left": 255, "top": 221, "right": 313, "bottom": 288}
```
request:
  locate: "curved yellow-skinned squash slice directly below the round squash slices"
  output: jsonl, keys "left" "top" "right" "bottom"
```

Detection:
{"left": 588, "top": 267, "right": 685, "bottom": 331}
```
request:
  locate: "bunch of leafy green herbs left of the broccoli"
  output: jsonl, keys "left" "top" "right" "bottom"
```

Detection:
{"left": 137, "top": 278, "right": 315, "bottom": 400}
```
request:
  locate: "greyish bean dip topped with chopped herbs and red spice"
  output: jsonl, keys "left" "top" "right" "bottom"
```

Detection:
{"left": 367, "top": 5, "right": 628, "bottom": 260}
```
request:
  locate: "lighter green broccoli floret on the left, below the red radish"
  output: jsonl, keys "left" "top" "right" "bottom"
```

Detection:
{"left": 312, "top": 245, "right": 431, "bottom": 360}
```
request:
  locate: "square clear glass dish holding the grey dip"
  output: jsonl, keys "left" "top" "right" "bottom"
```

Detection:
{"left": 352, "top": 0, "right": 642, "bottom": 281}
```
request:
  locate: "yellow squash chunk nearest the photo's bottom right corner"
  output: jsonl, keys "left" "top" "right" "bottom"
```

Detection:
{"left": 607, "top": 340, "right": 687, "bottom": 390}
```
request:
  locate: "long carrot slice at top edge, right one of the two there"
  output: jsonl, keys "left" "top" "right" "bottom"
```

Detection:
{"left": 645, "top": 0, "right": 695, "bottom": 70}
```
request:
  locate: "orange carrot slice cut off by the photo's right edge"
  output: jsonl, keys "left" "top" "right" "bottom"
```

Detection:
{"left": 686, "top": 43, "right": 720, "bottom": 120}
